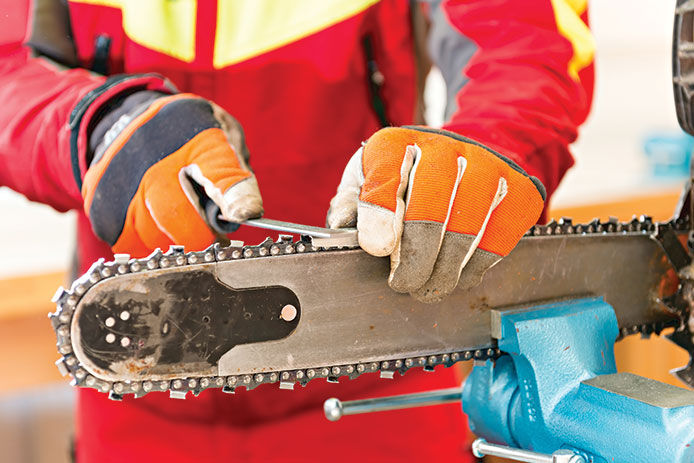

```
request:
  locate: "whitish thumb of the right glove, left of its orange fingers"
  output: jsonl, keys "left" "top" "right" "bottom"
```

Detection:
{"left": 326, "top": 147, "right": 364, "bottom": 228}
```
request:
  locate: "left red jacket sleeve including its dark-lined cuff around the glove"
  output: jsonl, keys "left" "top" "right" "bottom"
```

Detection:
{"left": 0, "top": 0, "right": 175, "bottom": 211}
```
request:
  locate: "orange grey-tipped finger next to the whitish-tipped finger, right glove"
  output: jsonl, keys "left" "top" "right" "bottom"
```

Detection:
{"left": 388, "top": 144, "right": 465, "bottom": 292}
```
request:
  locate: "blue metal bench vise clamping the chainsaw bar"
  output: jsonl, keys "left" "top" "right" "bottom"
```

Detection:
{"left": 463, "top": 298, "right": 694, "bottom": 463}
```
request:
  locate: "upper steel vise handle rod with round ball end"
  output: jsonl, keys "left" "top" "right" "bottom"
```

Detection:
{"left": 323, "top": 387, "right": 462, "bottom": 421}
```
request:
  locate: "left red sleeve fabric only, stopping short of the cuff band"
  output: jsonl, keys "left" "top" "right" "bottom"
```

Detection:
{"left": 0, "top": 0, "right": 105, "bottom": 211}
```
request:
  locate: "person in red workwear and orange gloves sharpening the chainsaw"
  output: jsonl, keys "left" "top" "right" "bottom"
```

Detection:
{"left": 0, "top": 0, "right": 593, "bottom": 462}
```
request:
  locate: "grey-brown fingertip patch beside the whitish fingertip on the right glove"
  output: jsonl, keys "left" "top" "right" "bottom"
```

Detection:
{"left": 390, "top": 222, "right": 443, "bottom": 293}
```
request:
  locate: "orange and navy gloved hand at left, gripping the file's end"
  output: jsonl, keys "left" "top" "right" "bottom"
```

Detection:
{"left": 82, "top": 91, "right": 263, "bottom": 256}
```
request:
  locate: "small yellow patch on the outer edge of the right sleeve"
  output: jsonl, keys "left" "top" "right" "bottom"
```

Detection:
{"left": 551, "top": 0, "right": 595, "bottom": 80}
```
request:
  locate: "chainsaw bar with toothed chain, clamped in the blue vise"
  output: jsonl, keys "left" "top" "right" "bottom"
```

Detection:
{"left": 50, "top": 209, "right": 694, "bottom": 399}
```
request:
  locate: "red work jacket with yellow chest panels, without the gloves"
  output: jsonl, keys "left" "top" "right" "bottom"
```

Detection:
{"left": 0, "top": 0, "right": 592, "bottom": 462}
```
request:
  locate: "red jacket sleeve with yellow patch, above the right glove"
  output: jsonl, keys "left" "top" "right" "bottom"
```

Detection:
{"left": 444, "top": 0, "right": 594, "bottom": 201}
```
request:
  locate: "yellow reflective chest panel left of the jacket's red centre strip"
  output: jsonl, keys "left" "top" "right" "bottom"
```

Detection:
{"left": 72, "top": 0, "right": 198, "bottom": 63}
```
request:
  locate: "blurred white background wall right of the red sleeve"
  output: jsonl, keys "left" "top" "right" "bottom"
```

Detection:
{"left": 554, "top": 0, "right": 681, "bottom": 206}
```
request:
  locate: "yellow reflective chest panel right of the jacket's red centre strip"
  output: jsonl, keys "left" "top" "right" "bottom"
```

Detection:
{"left": 214, "top": 0, "right": 378, "bottom": 68}
